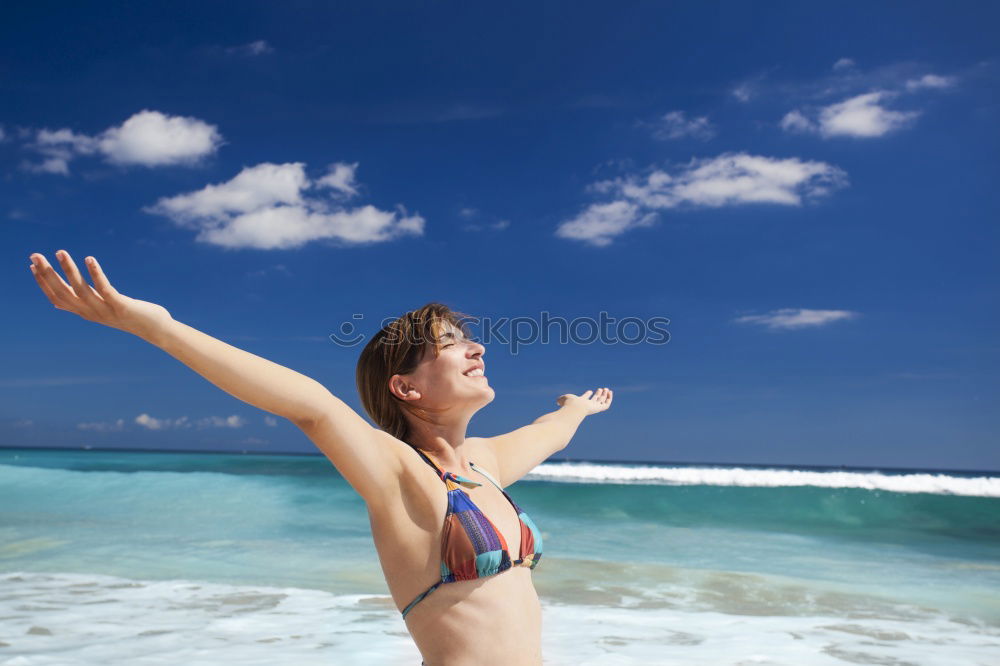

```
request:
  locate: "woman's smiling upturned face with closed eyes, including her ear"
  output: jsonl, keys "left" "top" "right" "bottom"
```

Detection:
{"left": 392, "top": 322, "right": 496, "bottom": 410}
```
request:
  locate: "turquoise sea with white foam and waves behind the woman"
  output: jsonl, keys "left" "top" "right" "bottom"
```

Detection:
{"left": 0, "top": 449, "right": 1000, "bottom": 666}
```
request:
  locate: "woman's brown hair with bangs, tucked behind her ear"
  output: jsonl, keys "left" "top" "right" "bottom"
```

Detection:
{"left": 355, "top": 303, "right": 471, "bottom": 442}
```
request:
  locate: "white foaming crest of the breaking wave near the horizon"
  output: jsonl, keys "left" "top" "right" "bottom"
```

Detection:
{"left": 526, "top": 463, "right": 1000, "bottom": 497}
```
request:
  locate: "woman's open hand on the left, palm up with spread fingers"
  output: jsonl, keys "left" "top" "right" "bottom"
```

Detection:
{"left": 31, "top": 250, "right": 173, "bottom": 339}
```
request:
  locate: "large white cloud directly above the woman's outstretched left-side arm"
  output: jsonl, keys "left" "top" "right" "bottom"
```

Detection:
{"left": 146, "top": 162, "right": 424, "bottom": 250}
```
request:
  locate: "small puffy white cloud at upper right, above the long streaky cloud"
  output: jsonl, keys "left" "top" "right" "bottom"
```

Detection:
{"left": 781, "top": 90, "right": 920, "bottom": 139}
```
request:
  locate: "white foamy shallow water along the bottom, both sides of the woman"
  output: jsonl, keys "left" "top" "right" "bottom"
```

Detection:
{"left": 0, "top": 573, "right": 1000, "bottom": 666}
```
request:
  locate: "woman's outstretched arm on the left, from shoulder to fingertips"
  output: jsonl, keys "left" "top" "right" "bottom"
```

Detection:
{"left": 24, "top": 251, "right": 400, "bottom": 501}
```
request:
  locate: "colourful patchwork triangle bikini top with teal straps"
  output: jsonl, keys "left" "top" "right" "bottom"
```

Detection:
{"left": 402, "top": 444, "right": 542, "bottom": 618}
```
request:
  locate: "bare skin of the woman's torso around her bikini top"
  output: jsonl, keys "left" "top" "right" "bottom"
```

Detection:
{"left": 368, "top": 435, "right": 542, "bottom": 666}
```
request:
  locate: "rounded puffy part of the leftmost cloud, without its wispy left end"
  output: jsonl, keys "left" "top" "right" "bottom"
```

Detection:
{"left": 97, "top": 111, "right": 222, "bottom": 167}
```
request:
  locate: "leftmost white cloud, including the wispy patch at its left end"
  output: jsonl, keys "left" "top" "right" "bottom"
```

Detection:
{"left": 22, "top": 110, "right": 222, "bottom": 175}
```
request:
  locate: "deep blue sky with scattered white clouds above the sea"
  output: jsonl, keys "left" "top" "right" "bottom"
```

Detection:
{"left": 0, "top": 1, "right": 1000, "bottom": 470}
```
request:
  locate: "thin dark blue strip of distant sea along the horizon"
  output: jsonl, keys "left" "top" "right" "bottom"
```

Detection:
{"left": 0, "top": 444, "right": 1000, "bottom": 477}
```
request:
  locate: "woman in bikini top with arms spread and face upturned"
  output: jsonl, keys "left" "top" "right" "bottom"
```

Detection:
{"left": 30, "top": 250, "right": 612, "bottom": 666}
